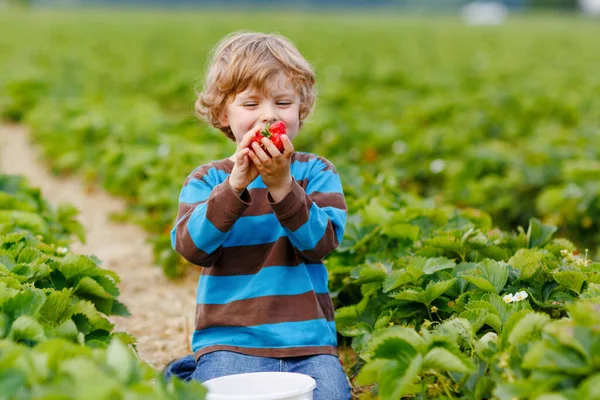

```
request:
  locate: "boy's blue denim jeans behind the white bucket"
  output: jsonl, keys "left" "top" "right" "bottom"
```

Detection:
{"left": 165, "top": 351, "right": 350, "bottom": 400}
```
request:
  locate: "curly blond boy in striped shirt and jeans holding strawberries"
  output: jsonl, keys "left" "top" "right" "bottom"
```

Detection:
{"left": 166, "top": 32, "right": 350, "bottom": 400}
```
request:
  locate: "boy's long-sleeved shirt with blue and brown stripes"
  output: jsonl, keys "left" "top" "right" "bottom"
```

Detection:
{"left": 171, "top": 152, "right": 347, "bottom": 360}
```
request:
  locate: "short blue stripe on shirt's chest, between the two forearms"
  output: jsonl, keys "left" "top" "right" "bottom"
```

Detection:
{"left": 223, "top": 213, "right": 285, "bottom": 247}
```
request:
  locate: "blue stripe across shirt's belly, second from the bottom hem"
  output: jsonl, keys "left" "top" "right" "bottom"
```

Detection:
{"left": 196, "top": 261, "right": 329, "bottom": 304}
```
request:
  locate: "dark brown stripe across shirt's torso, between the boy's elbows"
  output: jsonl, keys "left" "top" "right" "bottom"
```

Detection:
{"left": 207, "top": 236, "right": 306, "bottom": 276}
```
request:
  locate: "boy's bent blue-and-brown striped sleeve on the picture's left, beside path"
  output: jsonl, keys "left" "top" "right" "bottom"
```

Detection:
{"left": 171, "top": 167, "right": 251, "bottom": 267}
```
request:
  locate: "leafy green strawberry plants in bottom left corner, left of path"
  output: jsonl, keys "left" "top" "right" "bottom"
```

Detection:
{"left": 0, "top": 174, "right": 206, "bottom": 400}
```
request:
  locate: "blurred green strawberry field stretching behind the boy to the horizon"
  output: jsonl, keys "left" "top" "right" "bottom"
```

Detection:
{"left": 0, "top": 11, "right": 600, "bottom": 276}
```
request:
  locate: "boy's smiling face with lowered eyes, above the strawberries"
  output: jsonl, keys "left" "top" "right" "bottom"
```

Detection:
{"left": 222, "top": 72, "right": 300, "bottom": 143}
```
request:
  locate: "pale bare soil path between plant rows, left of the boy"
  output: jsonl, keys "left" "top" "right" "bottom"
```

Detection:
{"left": 0, "top": 126, "right": 198, "bottom": 368}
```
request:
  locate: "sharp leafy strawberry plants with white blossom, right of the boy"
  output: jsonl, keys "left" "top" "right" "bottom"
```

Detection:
{"left": 329, "top": 177, "right": 600, "bottom": 400}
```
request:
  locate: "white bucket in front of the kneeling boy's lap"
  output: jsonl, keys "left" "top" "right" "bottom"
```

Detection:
{"left": 203, "top": 372, "right": 317, "bottom": 400}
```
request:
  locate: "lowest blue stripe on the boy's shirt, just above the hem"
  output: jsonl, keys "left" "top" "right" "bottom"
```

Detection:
{"left": 192, "top": 319, "right": 337, "bottom": 352}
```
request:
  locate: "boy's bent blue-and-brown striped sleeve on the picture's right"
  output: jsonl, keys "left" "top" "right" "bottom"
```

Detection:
{"left": 267, "top": 157, "right": 347, "bottom": 262}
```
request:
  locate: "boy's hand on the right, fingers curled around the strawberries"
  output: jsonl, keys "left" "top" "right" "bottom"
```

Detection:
{"left": 248, "top": 135, "right": 294, "bottom": 202}
